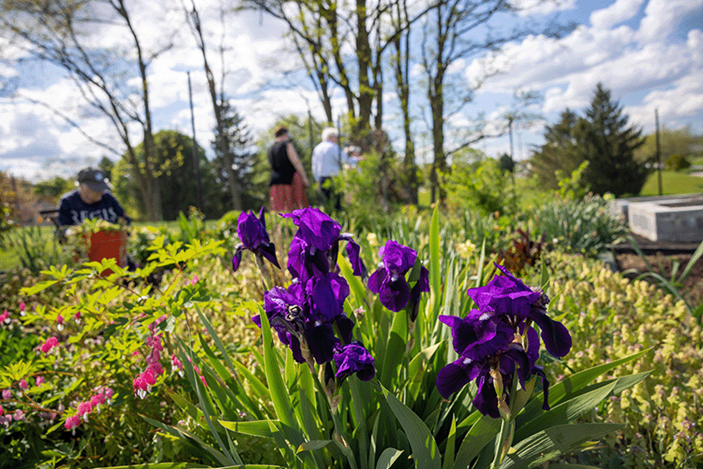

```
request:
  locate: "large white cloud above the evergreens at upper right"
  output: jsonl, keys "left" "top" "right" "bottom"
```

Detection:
{"left": 466, "top": 0, "right": 703, "bottom": 133}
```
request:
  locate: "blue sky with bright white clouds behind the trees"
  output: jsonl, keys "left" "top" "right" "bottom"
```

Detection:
{"left": 0, "top": 0, "right": 703, "bottom": 181}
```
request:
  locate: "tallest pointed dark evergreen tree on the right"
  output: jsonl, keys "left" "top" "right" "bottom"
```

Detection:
{"left": 575, "top": 83, "right": 648, "bottom": 196}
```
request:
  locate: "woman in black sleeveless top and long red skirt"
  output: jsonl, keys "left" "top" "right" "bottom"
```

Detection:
{"left": 268, "top": 125, "right": 310, "bottom": 213}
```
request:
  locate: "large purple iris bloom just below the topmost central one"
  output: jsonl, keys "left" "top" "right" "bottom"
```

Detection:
{"left": 252, "top": 273, "right": 354, "bottom": 364}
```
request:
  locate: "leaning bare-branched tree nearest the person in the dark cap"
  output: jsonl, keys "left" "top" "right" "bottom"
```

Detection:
{"left": 0, "top": 0, "right": 171, "bottom": 220}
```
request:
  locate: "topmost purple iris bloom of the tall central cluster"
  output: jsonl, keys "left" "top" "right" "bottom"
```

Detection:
{"left": 283, "top": 207, "right": 366, "bottom": 280}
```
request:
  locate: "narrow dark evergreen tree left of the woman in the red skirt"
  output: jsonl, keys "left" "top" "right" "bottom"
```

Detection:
{"left": 212, "top": 100, "right": 265, "bottom": 210}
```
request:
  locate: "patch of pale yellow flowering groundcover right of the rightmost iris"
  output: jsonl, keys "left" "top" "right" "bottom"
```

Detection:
{"left": 550, "top": 254, "right": 703, "bottom": 468}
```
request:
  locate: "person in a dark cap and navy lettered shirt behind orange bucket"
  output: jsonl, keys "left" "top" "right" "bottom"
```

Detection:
{"left": 59, "top": 167, "right": 131, "bottom": 226}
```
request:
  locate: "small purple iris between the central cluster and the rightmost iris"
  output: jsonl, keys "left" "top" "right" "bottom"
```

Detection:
{"left": 369, "top": 240, "right": 430, "bottom": 312}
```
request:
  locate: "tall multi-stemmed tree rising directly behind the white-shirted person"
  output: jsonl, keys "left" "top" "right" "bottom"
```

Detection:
{"left": 245, "top": 0, "right": 427, "bottom": 137}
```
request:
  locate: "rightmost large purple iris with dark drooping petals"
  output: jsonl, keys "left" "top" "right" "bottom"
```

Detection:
{"left": 437, "top": 266, "right": 571, "bottom": 418}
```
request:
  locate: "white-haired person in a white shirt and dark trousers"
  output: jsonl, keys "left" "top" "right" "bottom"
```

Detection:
{"left": 312, "top": 127, "right": 356, "bottom": 210}
